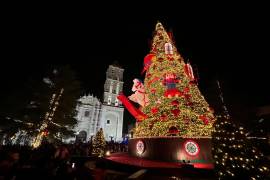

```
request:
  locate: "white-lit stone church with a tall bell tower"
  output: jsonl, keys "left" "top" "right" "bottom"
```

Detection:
{"left": 74, "top": 65, "right": 124, "bottom": 142}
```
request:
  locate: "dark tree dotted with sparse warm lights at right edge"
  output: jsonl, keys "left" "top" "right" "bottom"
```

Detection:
{"left": 212, "top": 82, "right": 269, "bottom": 180}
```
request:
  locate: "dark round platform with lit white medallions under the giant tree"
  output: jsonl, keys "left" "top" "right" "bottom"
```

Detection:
{"left": 128, "top": 136, "right": 213, "bottom": 167}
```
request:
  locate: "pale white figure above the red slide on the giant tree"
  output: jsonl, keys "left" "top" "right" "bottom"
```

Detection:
{"left": 128, "top": 79, "right": 149, "bottom": 107}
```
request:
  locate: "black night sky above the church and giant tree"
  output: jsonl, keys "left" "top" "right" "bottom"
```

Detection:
{"left": 0, "top": 5, "right": 270, "bottom": 128}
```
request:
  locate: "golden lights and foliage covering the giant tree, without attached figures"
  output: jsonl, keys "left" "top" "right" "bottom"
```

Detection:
{"left": 131, "top": 23, "right": 216, "bottom": 138}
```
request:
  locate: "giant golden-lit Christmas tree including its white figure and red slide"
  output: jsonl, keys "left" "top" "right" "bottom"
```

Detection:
{"left": 118, "top": 23, "right": 215, "bottom": 137}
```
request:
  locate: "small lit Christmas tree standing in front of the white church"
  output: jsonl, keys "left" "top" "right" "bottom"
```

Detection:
{"left": 93, "top": 128, "right": 106, "bottom": 157}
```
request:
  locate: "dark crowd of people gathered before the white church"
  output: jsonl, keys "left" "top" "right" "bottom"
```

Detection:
{"left": 0, "top": 142, "right": 127, "bottom": 180}
